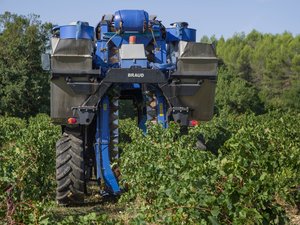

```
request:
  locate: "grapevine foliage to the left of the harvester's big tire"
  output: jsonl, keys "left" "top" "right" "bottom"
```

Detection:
{"left": 0, "top": 114, "right": 59, "bottom": 223}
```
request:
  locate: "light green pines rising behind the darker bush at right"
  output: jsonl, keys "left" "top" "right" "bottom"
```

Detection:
{"left": 217, "top": 30, "right": 300, "bottom": 110}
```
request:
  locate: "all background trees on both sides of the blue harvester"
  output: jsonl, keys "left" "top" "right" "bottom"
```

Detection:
{"left": 0, "top": 12, "right": 300, "bottom": 117}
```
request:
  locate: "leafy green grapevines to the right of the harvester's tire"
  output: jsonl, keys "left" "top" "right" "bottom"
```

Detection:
{"left": 121, "top": 112, "right": 300, "bottom": 224}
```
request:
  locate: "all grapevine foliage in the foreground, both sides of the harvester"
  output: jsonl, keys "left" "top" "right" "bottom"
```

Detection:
{"left": 0, "top": 111, "right": 300, "bottom": 224}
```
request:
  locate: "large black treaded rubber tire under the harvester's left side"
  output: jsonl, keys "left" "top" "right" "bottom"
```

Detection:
{"left": 56, "top": 133, "right": 85, "bottom": 206}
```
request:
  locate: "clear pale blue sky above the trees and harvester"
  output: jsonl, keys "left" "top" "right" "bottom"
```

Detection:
{"left": 0, "top": 0, "right": 300, "bottom": 39}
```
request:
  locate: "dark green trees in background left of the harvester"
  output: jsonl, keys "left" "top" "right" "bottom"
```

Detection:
{"left": 0, "top": 12, "right": 52, "bottom": 117}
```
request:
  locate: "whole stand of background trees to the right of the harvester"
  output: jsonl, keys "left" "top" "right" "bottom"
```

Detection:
{"left": 201, "top": 30, "right": 300, "bottom": 113}
